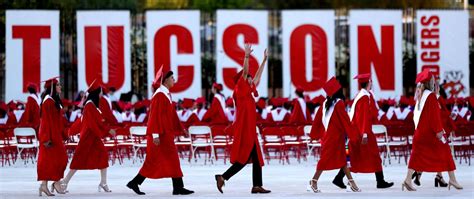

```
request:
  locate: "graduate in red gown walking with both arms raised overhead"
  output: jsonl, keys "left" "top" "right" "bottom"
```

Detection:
{"left": 215, "top": 44, "right": 270, "bottom": 193}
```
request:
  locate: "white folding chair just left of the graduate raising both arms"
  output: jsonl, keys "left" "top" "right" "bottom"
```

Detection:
{"left": 188, "top": 126, "right": 214, "bottom": 164}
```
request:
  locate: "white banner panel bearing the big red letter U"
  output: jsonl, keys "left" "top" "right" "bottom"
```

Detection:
{"left": 77, "top": 10, "right": 131, "bottom": 93}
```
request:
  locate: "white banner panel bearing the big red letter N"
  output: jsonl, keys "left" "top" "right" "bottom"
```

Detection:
{"left": 349, "top": 10, "right": 403, "bottom": 98}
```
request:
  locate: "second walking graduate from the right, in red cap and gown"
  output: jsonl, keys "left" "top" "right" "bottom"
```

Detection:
{"left": 349, "top": 73, "right": 393, "bottom": 188}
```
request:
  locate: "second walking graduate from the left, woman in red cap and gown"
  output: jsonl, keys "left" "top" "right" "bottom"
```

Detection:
{"left": 64, "top": 80, "right": 115, "bottom": 192}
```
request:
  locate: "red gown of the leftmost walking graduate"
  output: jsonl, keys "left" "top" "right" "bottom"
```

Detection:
{"left": 35, "top": 96, "right": 68, "bottom": 181}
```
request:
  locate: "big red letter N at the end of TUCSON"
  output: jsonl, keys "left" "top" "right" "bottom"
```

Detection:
{"left": 357, "top": 26, "right": 395, "bottom": 90}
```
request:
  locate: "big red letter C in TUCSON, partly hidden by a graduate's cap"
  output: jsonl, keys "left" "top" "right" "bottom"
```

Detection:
{"left": 154, "top": 25, "right": 193, "bottom": 92}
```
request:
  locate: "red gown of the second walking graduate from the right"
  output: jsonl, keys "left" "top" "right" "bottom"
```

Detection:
{"left": 349, "top": 95, "right": 382, "bottom": 173}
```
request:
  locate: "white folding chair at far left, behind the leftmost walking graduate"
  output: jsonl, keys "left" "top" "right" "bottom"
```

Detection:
{"left": 13, "top": 127, "right": 39, "bottom": 164}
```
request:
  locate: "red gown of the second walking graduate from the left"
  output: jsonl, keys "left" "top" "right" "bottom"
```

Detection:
{"left": 70, "top": 101, "right": 110, "bottom": 170}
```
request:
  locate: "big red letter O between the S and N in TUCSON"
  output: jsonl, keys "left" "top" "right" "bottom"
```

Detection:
{"left": 290, "top": 25, "right": 328, "bottom": 91}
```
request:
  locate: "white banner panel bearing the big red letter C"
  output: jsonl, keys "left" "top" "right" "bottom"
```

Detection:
{"left": 146, "top": 11, "right": 201, "bottom": 101}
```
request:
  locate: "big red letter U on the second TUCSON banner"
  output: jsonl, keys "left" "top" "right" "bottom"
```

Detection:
{"left": 84, "top": 26, "right": 125, "bottom": 89}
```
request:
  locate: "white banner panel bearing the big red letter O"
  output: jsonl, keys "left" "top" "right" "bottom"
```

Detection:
{"left": 282, "top": 10, "right": 335, "bottom": 98}
